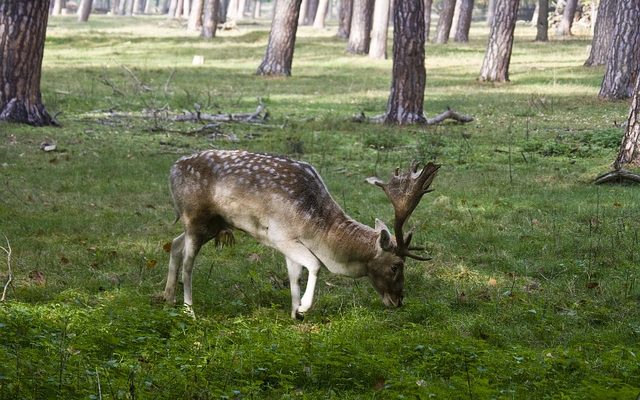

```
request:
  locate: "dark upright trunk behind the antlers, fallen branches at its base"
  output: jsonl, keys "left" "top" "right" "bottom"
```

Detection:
{"left": 385, "top": 1, "right": 426, "bottom": 124}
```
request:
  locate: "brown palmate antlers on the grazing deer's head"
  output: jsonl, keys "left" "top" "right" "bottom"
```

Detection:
{"left": 367, "top": 161, "right": 440, "bottom": 261}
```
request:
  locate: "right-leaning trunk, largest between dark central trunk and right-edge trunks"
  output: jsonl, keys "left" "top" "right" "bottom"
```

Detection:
{"left": 480, "top": 0, "right": 519, "bottom": 82}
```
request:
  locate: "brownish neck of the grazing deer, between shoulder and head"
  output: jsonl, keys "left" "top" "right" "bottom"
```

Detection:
{"left": 305, "top": 212, "right": 378, "bottom": 277}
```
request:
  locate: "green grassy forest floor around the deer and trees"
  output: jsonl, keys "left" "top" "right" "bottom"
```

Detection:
{"left": 0, "top": 16, "right": 640, "bottom": 399}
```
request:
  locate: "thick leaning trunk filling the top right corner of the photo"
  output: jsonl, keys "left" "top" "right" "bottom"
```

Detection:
{"left": 598, "top": 1, "right": 640, "bottom": 100}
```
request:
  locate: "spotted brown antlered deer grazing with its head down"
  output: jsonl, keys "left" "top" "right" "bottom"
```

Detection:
{"left": 164, "top": 150, "right": 439, "bottom": 318}
